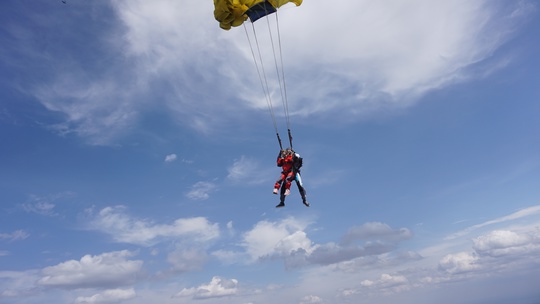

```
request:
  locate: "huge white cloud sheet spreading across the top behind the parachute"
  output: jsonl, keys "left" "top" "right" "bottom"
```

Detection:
{"left": 20, "top": 0, "right": 527, "bottom": 144}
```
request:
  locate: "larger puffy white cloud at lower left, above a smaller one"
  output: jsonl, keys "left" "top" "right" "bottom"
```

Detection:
{"left": 38, "top": 250, "right": 143, "bottom": 289}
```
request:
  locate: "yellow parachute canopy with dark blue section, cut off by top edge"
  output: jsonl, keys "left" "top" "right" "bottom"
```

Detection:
{"left": 214, "top": 0, "right": 302, "bottom": 30}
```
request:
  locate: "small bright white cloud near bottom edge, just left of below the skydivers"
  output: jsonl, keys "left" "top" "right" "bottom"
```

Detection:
{"left": 175, "top": 277, "right": 238, "bottom": 299}
